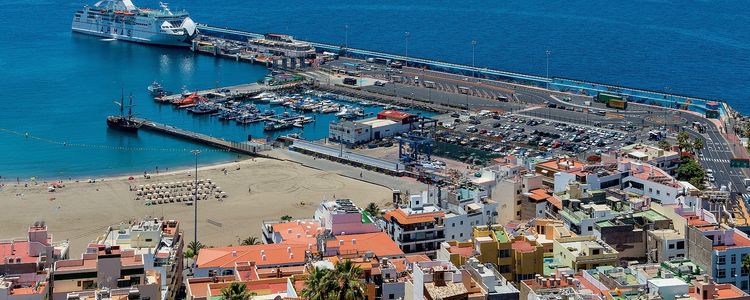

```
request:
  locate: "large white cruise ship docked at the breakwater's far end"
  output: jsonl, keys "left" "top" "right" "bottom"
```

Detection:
{"left": 72, "top": 0, "right": 196, "bottom": 47}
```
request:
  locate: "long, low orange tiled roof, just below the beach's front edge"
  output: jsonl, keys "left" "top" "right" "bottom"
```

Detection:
{"left": 197, "top": 244, "right": 314, "bottom": 268}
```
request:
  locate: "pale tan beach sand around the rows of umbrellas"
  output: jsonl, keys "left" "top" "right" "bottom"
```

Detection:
{"left": 0, "top": 158, "right": 391, "bottom": 258}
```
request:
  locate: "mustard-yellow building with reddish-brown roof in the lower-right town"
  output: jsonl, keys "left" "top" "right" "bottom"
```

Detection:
{"left": 472, "top": 225, "right": 544, "bottom": 281}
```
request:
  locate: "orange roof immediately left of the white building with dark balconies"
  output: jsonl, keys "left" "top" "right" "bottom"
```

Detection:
{"left": 326, "top": 232, "right": 404, "bottom": 257}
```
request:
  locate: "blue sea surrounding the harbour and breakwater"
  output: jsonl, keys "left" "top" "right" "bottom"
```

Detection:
{"left": 0, "top": 0, "right": 750, "bottom": 181}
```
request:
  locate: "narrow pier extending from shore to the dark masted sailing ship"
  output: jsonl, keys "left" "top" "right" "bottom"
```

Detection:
{"left": 132, "top": 117, "right": 271, "bottom": 156}
